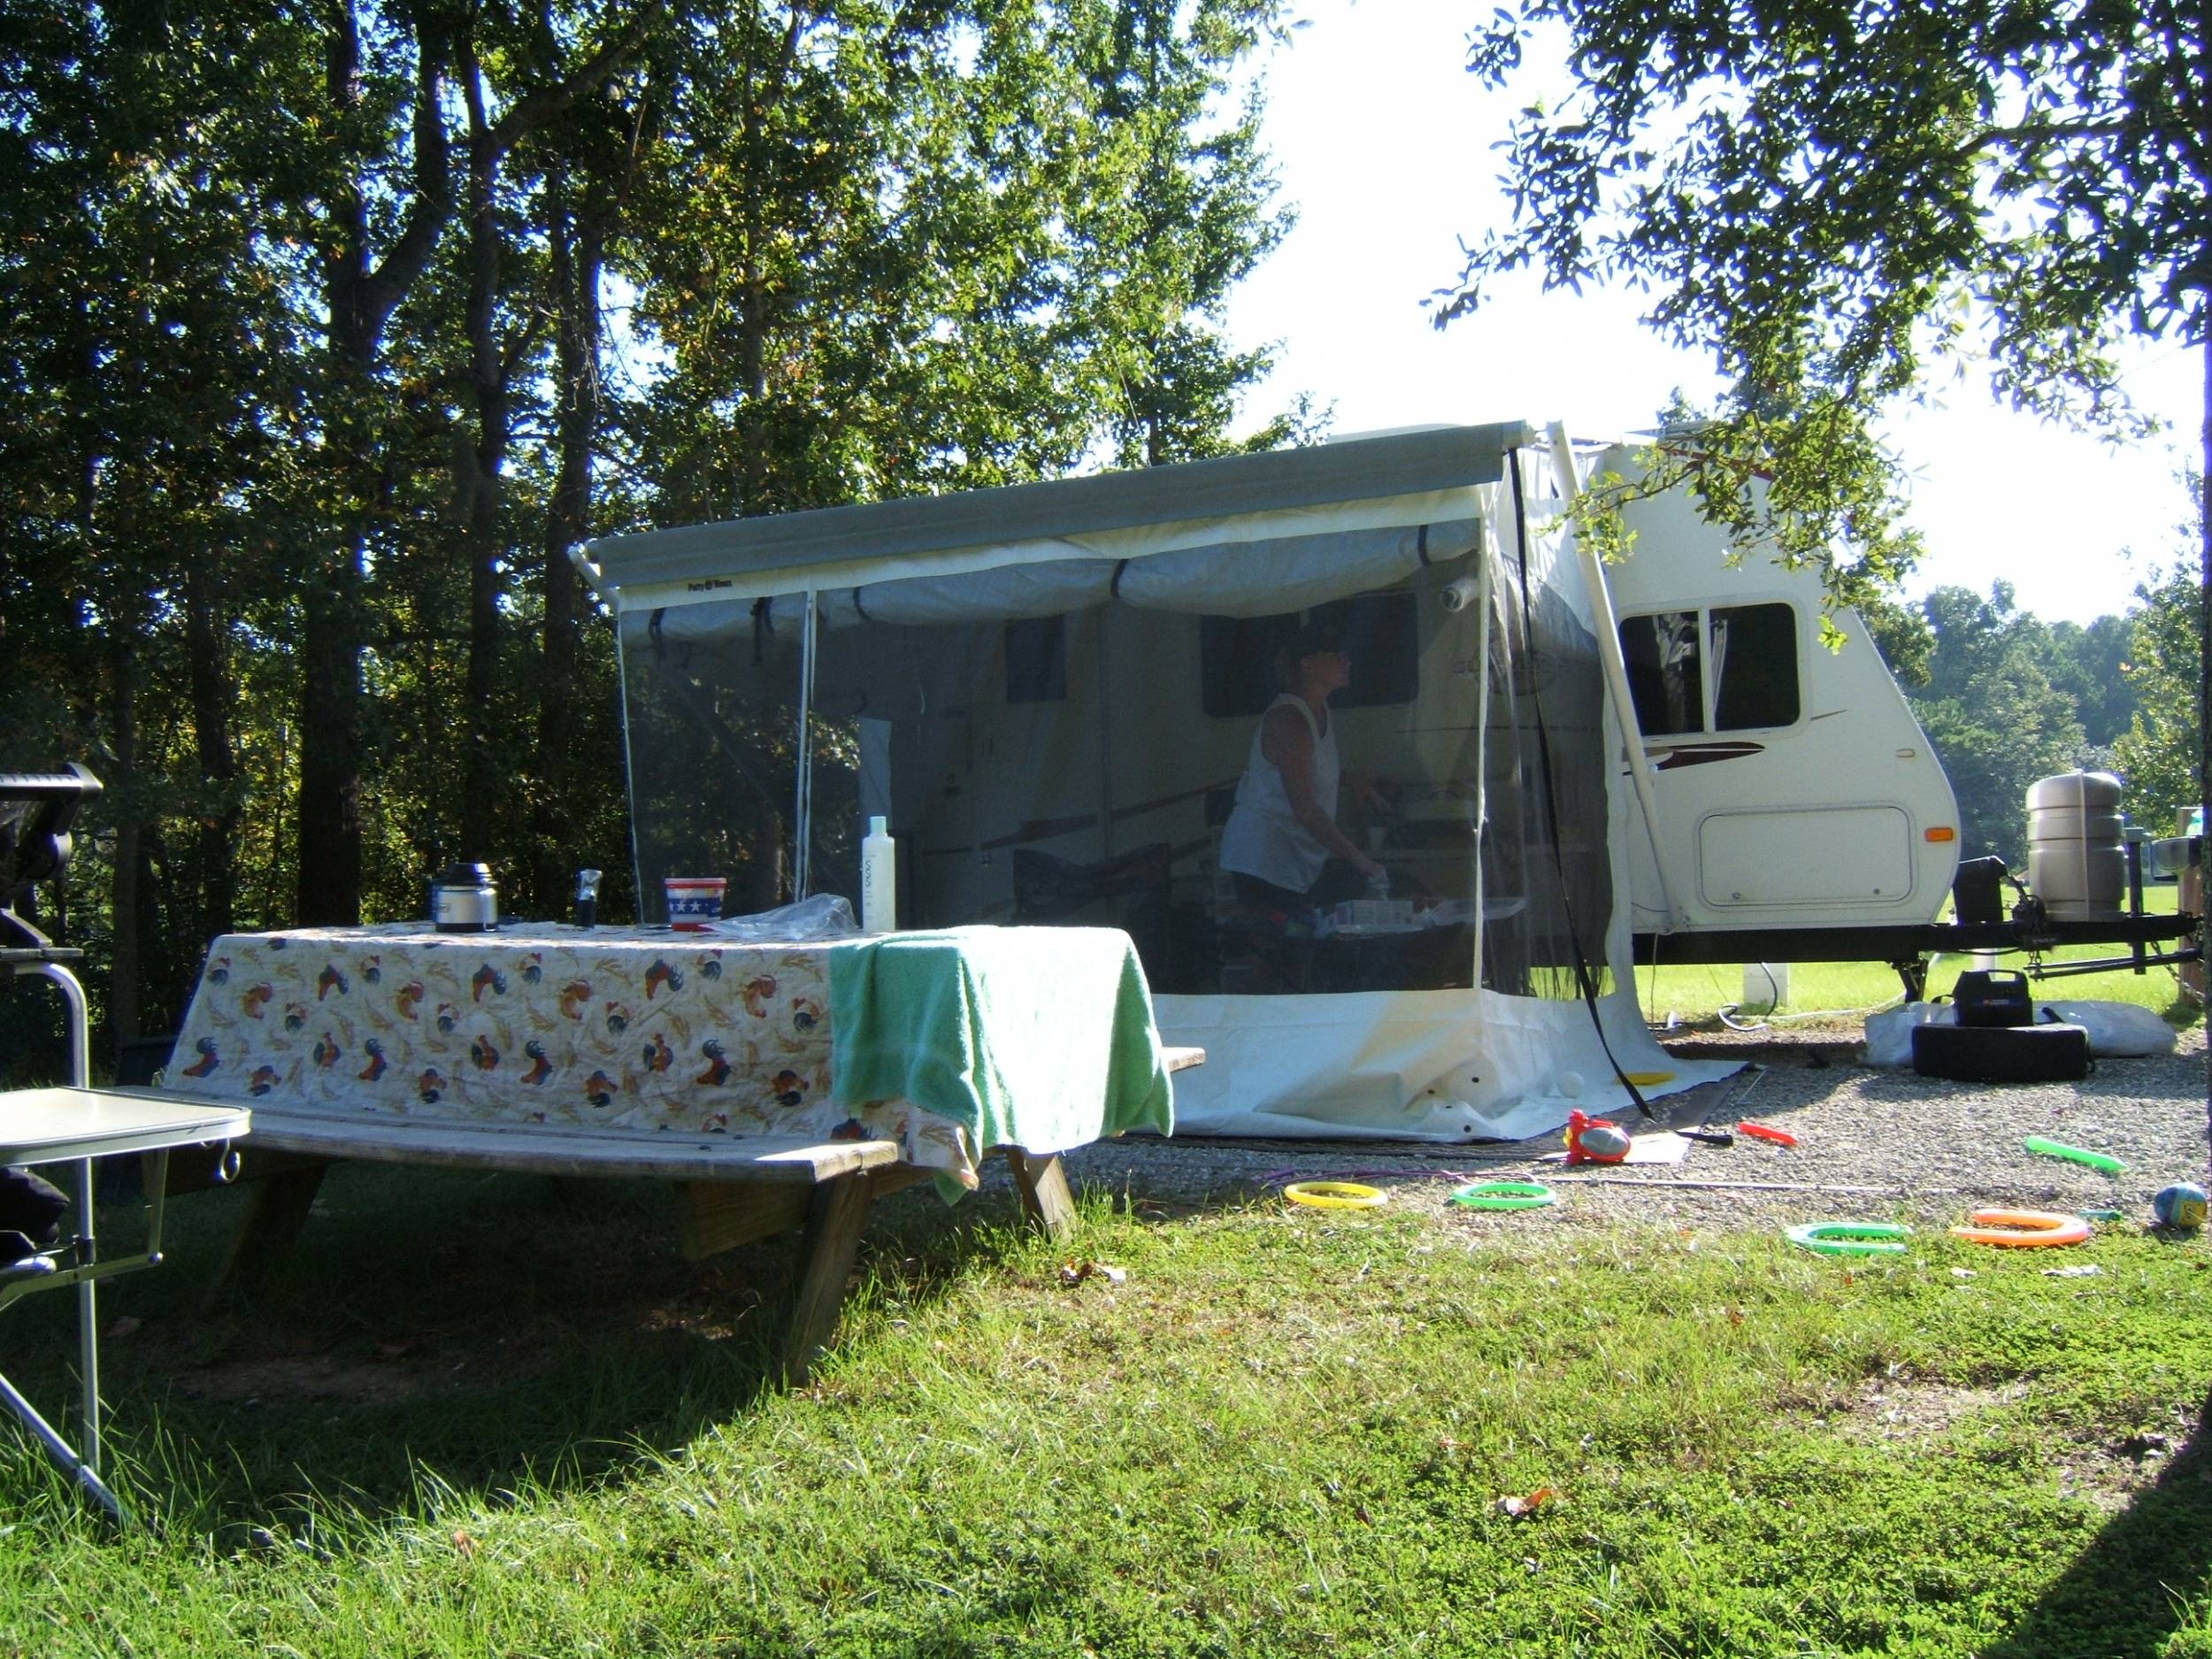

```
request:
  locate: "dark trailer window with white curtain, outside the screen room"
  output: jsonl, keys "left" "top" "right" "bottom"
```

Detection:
{"left": 1622, "top": 604, "right": 1801, "bottom": 737}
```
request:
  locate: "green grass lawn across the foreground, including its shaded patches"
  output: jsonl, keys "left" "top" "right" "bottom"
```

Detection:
{"left": 0, "top": 1171, "right": 2212, "bottom": 1659}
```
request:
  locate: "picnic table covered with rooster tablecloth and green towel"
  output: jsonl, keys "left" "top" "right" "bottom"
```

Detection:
{"left": 162, "top": 923, "right": 1203, "bottom": 1379}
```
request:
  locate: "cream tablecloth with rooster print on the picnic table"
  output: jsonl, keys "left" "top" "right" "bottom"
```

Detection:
{"left": 164, "top": 925, "right": 976, "bottom": 1188}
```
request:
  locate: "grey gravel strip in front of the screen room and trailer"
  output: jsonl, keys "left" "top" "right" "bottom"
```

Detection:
{"left": 1026, "top": 1026, "right": 2208, "bottom": 1233}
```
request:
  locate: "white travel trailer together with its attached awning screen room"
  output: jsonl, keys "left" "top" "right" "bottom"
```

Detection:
{"left": 578, "top": 423, "right": 2194, "bottom": 1140}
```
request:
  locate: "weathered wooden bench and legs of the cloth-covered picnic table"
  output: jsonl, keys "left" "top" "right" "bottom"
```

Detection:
{"left": 118, "top": 1048, "right": 1206, "bottom": 1385}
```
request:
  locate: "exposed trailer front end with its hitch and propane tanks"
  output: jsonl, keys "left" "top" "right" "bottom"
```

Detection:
{"left": 1584, "top": 447, "right": 2194, "bottom": 995}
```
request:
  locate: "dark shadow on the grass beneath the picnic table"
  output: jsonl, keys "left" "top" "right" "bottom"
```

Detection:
{"left": 9, "top": 1166, "right": 1013, "bottom": 1535}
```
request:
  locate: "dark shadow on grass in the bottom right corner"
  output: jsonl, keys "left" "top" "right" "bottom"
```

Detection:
{"left": 1980, "top": 1401, "right": 2212, "bottom": 1659}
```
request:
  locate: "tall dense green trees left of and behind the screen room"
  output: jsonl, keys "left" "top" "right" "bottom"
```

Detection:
{"left": 0, "top": 0, "right": 1305, "bottom": 1053}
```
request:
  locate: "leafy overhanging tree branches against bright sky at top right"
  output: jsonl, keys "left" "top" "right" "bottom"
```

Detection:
{"left": 1438, "top": 0, "right": 2212, "bottom": 600}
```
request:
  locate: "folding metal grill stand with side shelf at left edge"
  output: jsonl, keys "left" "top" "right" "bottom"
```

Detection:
{"left": 0, "top": 765, "right": 248, "bottom": 1522}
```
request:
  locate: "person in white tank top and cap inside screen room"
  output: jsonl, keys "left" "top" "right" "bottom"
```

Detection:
{"left": 1221, "top": 624, "right": 1389, "bottom": 914}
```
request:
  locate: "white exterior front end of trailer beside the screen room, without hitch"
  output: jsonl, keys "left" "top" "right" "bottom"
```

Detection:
{"left": 1595, "top": 447, "right": 1960, "bottom": 963}
